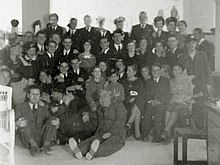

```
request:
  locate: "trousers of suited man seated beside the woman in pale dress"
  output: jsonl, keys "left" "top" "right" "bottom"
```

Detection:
{"left": 142, "top": 103, "right": 166, "bottom": 139}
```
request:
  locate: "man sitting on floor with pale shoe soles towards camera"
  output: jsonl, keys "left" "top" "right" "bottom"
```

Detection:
{"left": 69, "top": 90, "right": 127, "bottom": 160}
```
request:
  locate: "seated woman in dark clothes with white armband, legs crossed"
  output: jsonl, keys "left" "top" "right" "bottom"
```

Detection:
{"left": 123, "top": 64, "right": 145, "bottom": 140}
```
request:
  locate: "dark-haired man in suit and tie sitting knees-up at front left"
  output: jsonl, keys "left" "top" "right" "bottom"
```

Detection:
{"left": 15, "top": 85, "right": 59, "bottom": 156}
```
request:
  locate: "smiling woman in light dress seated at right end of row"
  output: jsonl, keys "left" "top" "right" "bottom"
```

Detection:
{"left": 161, "top": 64, "right": 194, "bottom": 139}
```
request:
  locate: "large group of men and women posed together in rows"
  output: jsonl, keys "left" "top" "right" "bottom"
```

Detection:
{"left": 0, "top": 11, "right": 214, "bottom": 160}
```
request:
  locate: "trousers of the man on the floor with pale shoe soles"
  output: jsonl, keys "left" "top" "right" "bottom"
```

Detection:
{"left": 79, "top": 135, "right": 124, "bottom": 157}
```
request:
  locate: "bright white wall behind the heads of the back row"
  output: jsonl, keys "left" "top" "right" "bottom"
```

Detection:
{"left": 50, "top": 0, "right": 183, "bottom": 31}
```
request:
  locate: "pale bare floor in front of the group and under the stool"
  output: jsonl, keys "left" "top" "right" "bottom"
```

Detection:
{"left": 15, "top": 138, "right": 207, "bottom": 165}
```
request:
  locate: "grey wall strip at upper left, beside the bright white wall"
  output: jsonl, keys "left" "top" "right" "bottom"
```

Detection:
{"left": 22, "top": 0, "right": 50, "bottom": 33}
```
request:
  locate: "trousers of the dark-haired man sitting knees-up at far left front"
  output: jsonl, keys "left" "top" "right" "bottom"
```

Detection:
{"left": 17, "top": 120, "right": 57, "bottom": 148}
